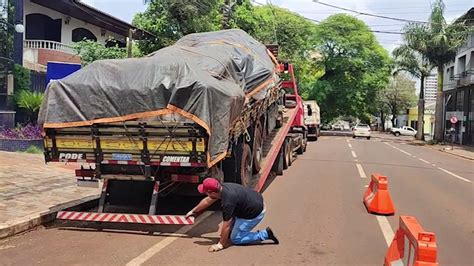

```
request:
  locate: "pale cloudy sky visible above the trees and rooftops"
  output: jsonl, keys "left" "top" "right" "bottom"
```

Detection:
{"left": 82, "top": 0, "right": 474, "bottom": 52}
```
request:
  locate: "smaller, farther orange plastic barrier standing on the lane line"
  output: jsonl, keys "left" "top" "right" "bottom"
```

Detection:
{"left": 364, "top": 173, "right": 395, "bottom": 215}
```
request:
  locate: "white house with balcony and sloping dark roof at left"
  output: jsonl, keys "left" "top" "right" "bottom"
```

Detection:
{"left": 0, "top": 0, "right": 151, "bottom": 127}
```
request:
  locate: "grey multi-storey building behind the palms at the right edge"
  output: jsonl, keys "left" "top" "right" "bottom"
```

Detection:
{"left": 443, "top": 8, "right": 474, "bottom": 145}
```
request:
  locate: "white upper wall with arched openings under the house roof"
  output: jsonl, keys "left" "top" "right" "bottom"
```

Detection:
{"left": 23, "top": 0, "right": 126, "bottom": 44}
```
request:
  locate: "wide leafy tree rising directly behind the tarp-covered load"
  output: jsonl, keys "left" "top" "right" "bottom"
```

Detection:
{"left": 133, "top": 0, "right": 321, "bottom": 99}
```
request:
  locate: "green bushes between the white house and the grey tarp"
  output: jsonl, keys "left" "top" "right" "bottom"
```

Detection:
{"left": 73, "top": 40, "right": 142, "bottom": 65}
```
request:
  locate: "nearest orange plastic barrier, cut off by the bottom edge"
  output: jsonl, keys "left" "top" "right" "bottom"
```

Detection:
{"left": 384, "top": 216, "right": 438, "bottom": 266}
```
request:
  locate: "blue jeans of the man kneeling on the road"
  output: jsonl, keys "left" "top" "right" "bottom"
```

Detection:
{"left": 230, "top": 209, "right": 268, "bottom": 245}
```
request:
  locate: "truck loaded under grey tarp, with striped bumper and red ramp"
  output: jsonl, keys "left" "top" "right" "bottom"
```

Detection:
{"left": 39, "top": 30, "right": 307, "bottom": 224}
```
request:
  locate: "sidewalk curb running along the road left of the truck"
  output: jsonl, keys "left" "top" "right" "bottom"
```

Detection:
{"left": 0, "top": 194, "right": 100, "bottom": 239}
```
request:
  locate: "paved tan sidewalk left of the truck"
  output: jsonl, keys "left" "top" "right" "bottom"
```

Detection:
{"left": 0, "top": 151, "right": 100, "bottom": 239}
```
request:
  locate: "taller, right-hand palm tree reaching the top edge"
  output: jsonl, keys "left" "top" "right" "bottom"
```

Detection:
{"left": 404, "top": 0, "right": 470, "bottom": 141}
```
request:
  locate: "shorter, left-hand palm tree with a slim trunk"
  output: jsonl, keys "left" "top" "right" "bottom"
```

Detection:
{"left": 392, "top": 46, "right": 434, "bottom": 140}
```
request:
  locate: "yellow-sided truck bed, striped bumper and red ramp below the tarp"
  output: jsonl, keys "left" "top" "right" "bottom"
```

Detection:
{"left": 44, "top": 46, "right": 307, "bottom": 227}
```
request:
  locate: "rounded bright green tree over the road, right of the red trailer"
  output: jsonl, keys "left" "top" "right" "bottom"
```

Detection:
{"left": 309, "top": 14, "right": 391, "bottom": 122}
